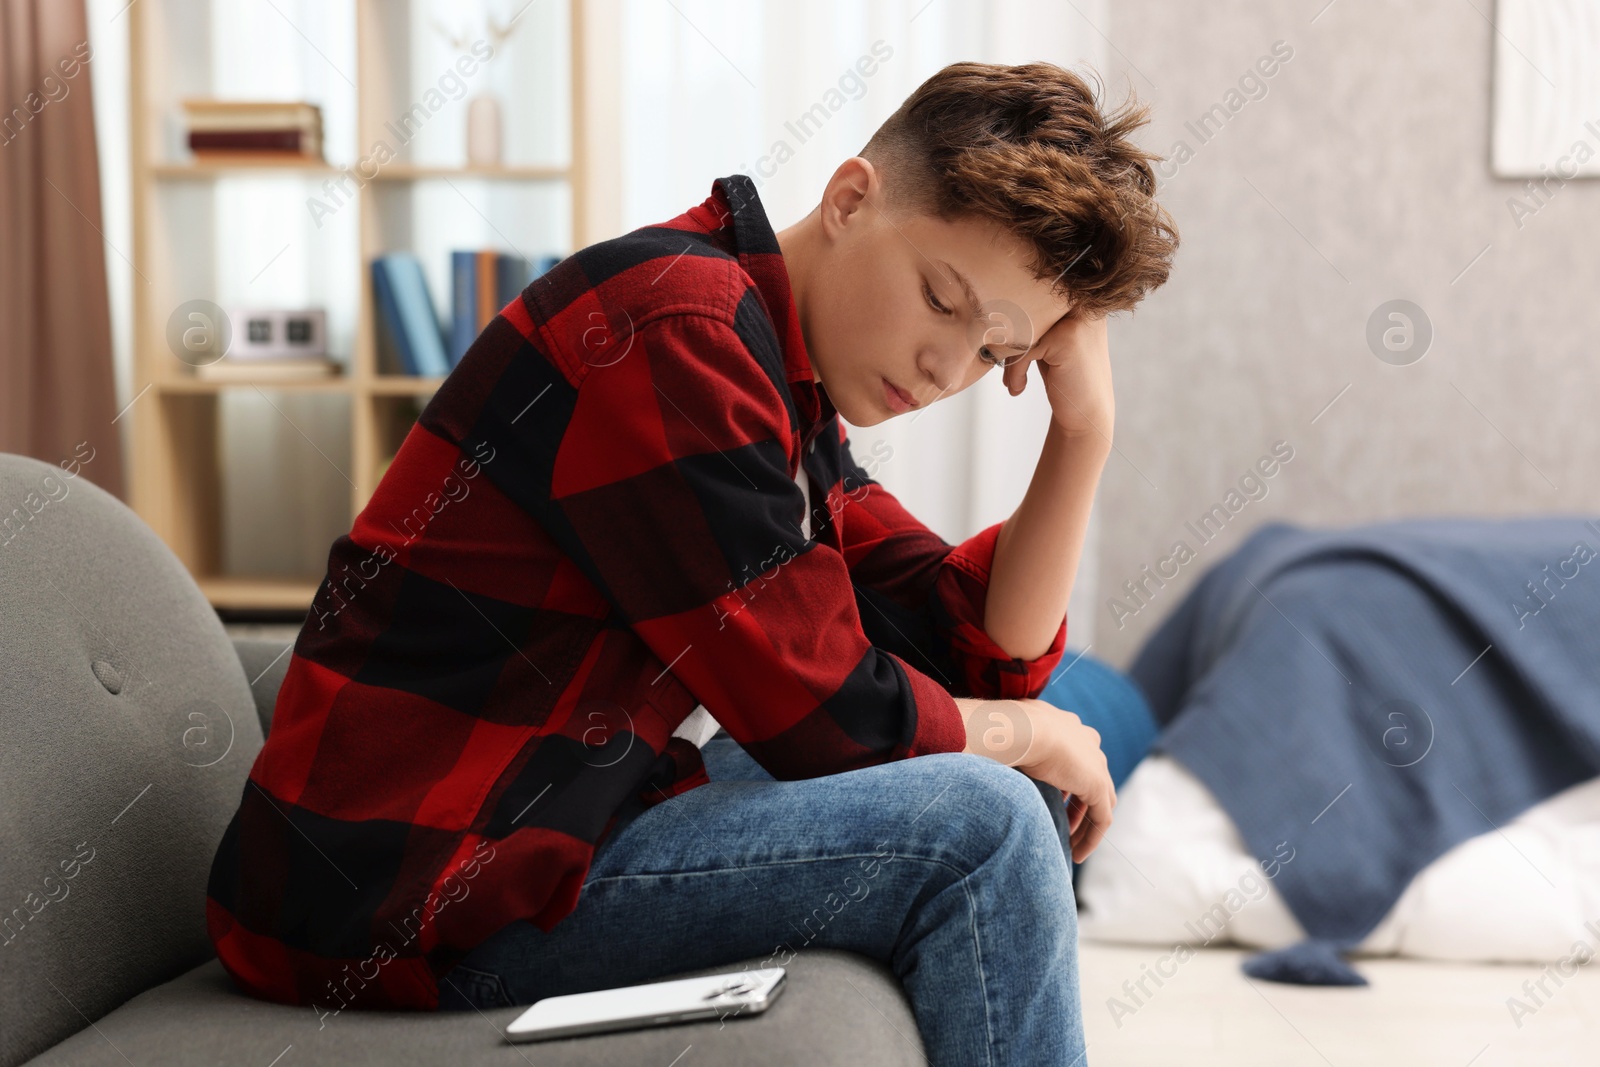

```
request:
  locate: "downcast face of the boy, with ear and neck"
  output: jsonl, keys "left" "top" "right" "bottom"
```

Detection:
{"left": 781, "top": 157, "right": 1067, "bottom": 426}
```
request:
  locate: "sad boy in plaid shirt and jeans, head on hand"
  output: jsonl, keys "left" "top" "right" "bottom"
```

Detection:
{"left": 208, "top": 62, "right": 1176, "bottom": 1064}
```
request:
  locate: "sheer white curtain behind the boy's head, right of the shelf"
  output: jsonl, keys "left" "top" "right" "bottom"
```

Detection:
{"left": 590, "top": 0, "right": 1120, "bottom": 648}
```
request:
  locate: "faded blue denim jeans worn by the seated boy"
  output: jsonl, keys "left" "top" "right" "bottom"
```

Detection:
{"left": 440, "top": 748, "right": 1085, "bottom": 1067}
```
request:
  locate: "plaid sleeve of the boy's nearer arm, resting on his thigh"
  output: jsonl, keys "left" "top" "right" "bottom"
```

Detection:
{"left": 537, "top": 303, "right": 966, "bottom": 779}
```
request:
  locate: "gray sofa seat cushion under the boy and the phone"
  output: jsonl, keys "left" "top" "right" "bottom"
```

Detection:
{"left": 18, "top": 949, "right": 926, "bottom": 1067}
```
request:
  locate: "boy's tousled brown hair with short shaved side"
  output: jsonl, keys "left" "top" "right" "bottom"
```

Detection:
{"left": 861, "top": 62, "right": 1178, "bottom": 315}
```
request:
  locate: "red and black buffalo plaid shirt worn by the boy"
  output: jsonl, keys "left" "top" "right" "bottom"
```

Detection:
{"left": 206, "top": 174, "right": 1066, "bottom": 1013}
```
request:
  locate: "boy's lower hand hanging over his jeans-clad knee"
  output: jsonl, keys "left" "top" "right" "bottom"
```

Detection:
{"left": 955, "top": 697, "right": 1117, "bottom": 864}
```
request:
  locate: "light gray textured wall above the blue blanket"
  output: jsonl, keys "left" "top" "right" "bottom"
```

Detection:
{"left": 1094, "top": 0, "right": 1600, "bottom": 664}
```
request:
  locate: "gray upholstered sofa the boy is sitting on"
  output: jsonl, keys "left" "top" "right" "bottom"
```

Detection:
{"left": 0, "top": 454, "right": 925, "bottom": 1067}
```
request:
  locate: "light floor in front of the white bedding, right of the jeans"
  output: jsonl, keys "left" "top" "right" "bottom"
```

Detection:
{"left": 1080, "top": 942, "right": 1600, "bottom": 1067}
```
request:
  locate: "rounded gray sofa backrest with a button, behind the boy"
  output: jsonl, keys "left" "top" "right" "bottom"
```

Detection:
{"left": 0, "top": 454, "right": 261, "bottom": 1067}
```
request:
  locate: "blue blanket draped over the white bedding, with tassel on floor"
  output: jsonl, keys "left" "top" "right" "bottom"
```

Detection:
{"left": 1131, "top": 517, "right": 1600, "bottom": 984}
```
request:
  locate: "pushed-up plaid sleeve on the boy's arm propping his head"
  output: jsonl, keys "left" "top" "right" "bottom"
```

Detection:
{"left": 840, "top": 424, "right": 1067, "bottom": 701}
